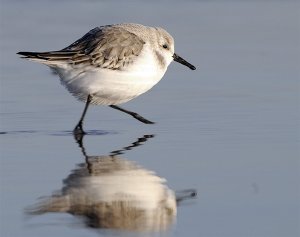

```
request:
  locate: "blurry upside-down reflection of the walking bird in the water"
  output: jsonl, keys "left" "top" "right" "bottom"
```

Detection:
{"left": 27, "top": 135, "right": 196, "bottom": 231}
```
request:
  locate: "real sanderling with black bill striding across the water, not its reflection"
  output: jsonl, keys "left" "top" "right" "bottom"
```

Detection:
{"left": 18, "top": 23, "right": 196, "bottom": 134}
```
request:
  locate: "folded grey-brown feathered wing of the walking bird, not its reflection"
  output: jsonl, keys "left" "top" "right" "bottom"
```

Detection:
{"left": 59, "top": 26, "right": 145, "bottom": 70}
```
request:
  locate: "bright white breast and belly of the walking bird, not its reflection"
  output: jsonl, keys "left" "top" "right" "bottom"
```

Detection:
{"left": 56, "top": 46, "right": 167, "bottom": 105}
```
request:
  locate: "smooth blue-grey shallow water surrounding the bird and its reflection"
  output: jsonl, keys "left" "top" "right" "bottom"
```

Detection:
{"left": 0, "top": 0, "right": 300, "bottom": 237}
